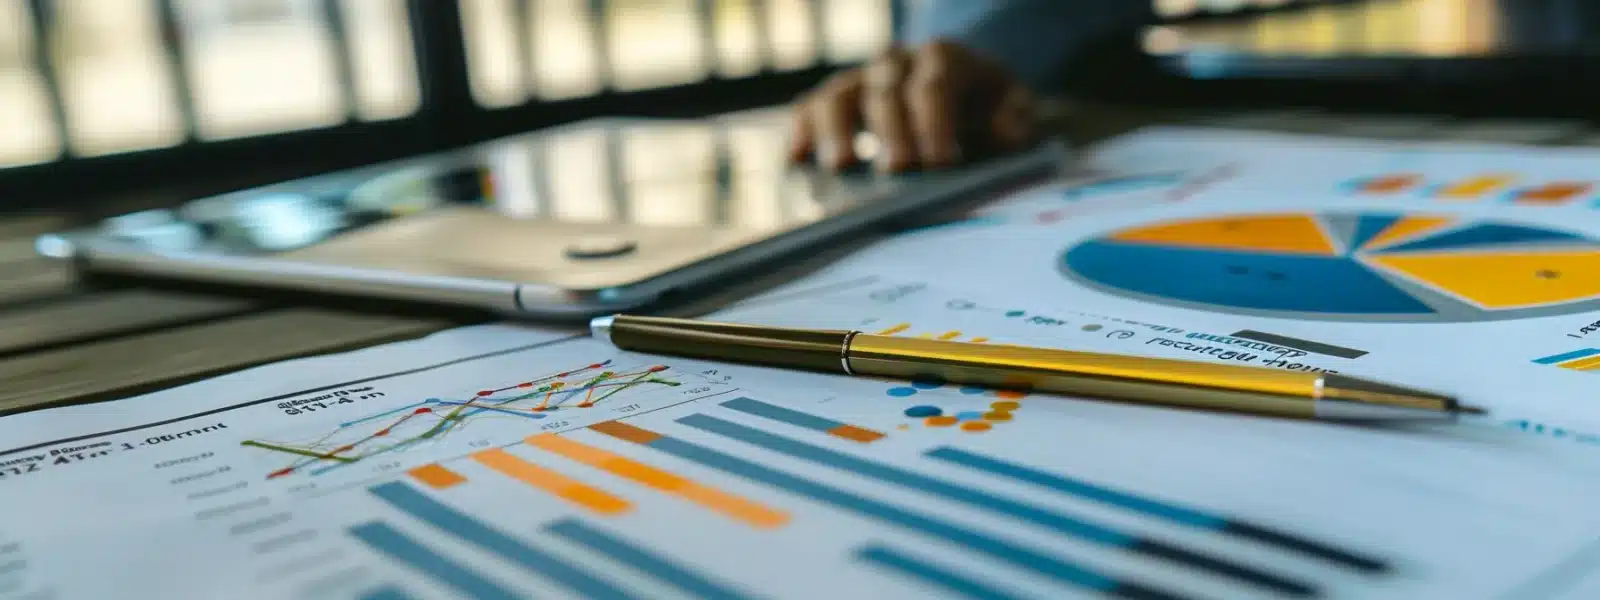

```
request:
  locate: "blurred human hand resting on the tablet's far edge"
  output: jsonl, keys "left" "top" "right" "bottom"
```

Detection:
{"left": 789, "top": 40, "right": 1034, "bottom": 171}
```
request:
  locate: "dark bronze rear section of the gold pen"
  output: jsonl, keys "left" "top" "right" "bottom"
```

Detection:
{"left": 610, "top": 315, "right": 851, "bottom": 373}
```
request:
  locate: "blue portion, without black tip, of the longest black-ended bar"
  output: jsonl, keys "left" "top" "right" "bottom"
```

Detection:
{"left": 678, "top": 414, "right": 1139, "bottom": 547}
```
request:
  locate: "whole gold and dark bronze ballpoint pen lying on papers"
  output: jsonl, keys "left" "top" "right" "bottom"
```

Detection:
{"left": 589, "top": 315, "right": 1483, "bottom": 421}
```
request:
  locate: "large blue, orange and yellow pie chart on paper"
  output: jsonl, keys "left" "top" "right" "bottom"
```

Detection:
{"left": 1061, "top": 211, "right": 1600, "bottom": 322}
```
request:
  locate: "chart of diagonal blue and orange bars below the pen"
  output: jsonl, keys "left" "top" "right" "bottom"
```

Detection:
{"left": 337, "top": 397, "right": 1394, "bottom": 600}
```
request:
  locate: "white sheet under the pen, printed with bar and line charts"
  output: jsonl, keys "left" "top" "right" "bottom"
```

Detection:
{"left": 0, "top": 278, "right": 1600, "bottom": 600}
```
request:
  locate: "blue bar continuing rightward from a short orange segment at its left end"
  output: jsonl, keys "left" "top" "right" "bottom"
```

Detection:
{"left": 624, "top": 437, "right": 1184, "bottom": 600}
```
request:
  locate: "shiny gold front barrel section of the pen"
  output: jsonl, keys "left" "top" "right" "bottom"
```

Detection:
{"left": 848, "top": 334, "right": 1322, "bottom": 419}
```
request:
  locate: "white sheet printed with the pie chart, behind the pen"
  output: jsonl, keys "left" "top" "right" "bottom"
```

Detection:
{"left": 830, "top": 130, "right": 1600, "bottom": 443}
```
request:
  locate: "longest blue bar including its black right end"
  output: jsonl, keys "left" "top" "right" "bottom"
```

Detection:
{"left": 677, "top": 414, "right": 1315, "bottom": 597}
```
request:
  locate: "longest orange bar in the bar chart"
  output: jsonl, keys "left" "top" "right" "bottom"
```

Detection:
{"left": 523, "top": 432, "right": 789, "bottom": 528}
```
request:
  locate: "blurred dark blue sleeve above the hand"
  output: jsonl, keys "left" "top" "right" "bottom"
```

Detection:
{"left": 901, "top": 0, "right": 1154, "bottom": 91}
